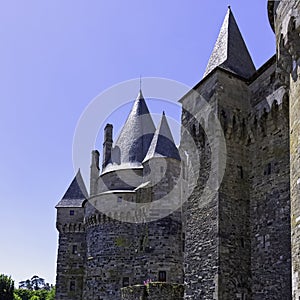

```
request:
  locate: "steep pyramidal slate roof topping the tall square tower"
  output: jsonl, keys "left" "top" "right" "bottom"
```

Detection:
{"left": 204, "top": 6, "right": 256, "bottom": 78}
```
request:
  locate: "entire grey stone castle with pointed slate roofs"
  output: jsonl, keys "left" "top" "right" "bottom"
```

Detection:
{"left": 56, "top": 0, "right": 300, "bottom": 300}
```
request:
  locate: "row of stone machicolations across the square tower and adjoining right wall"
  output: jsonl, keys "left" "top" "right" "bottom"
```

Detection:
{"left": 189, "top": 88, "right": 289, "bottom": 147}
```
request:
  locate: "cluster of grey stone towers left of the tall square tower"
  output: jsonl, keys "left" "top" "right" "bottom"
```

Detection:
{"left": 56, "top": 92, "right": 183, "bottom": 300}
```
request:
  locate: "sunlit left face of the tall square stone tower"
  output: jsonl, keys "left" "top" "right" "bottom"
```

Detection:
{"left": 180, "top": 73, "right": 219, "bottom": 299}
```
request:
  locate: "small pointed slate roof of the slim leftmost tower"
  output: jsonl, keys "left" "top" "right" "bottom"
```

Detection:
{"left": 56, "top": 170, "right": 88, "bottom": 207}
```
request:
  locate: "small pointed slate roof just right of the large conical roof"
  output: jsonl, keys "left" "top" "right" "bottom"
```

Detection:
{"left": 144, "top": 112, "right": 181, "bottom": 161}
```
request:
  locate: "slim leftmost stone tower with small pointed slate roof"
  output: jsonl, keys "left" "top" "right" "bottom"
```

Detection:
{"left": 56, "top": 171, "right": 88, "bottom": 300}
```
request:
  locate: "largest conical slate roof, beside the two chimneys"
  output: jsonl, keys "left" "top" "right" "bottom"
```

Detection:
{"left": 112, "top": 90, "right": 155, "bottom": 164}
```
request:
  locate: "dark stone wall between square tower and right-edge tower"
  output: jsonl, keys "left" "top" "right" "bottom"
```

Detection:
{"left": 249, "top": 59, "right": 291, "bottom": 300}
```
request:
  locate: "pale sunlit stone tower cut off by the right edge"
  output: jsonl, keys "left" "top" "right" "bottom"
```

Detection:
{"left": 268, "top": 0, "right": 300, "bottom": 299}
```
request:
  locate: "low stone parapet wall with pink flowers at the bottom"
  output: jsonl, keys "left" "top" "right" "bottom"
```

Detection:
{"left": 121, "top": 282, "right": 184, "bottom": 300}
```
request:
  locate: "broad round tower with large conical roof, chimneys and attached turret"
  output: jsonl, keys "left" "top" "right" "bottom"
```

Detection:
{"left": 83, "top": 91, "right": 183, "bottom": 300}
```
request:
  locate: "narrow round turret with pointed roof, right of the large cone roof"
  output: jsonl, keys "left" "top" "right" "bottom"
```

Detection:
{"left": 136, "top": 113, "right": 183, "bottom": 284}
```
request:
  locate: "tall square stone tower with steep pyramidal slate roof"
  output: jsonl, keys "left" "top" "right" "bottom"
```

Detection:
{"left": 180, "top": 8, "right": 255, "bottom": 299}
